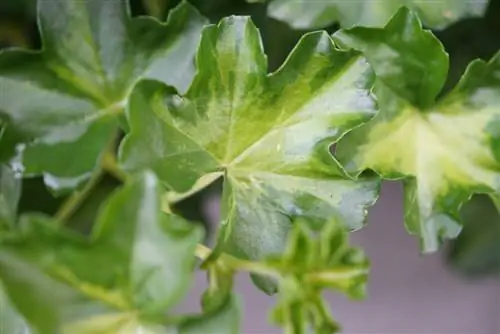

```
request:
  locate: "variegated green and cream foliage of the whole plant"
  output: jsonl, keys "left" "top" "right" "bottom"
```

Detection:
{"left": 0, "top": 0, "right": 500, "bottom": 334}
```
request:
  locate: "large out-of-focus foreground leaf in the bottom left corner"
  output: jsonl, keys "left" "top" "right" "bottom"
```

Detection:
{"left": 0, "top": 172, "right": 202, "bottom": 334}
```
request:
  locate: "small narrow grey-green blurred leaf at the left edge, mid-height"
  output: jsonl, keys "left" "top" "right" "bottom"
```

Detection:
{"left": 0, "top": 165, "right": 21, "bottom": 230}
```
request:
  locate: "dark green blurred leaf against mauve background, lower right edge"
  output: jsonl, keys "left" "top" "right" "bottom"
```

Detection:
{"left": 447, "top": 195, "right": 500, "bottom": 278}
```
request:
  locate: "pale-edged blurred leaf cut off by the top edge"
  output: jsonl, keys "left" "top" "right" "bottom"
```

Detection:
{"left": 268, "top": 0, "right": 488, "bottom": 29}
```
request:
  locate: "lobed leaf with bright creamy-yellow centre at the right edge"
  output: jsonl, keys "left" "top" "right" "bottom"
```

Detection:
{"left": 334, "top": 9, "right": 500, "bottom": 252}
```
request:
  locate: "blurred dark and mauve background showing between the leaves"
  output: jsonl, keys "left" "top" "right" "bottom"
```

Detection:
{"left": 0, "top": 0, "right": 500, "bottom": 334}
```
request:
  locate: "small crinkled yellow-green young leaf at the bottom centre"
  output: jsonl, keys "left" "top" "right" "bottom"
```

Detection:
{"left": 266, "top": 221, "right": 369, "bottom": 334}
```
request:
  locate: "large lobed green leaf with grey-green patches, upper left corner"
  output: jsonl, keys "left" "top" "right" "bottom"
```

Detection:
{"left": 0, "top": 0, "right": 206, "bottom": 190}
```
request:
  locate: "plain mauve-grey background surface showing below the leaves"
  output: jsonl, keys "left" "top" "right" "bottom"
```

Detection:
{"left": 177, "top": 182, "right": 500, "bottom": 334}
